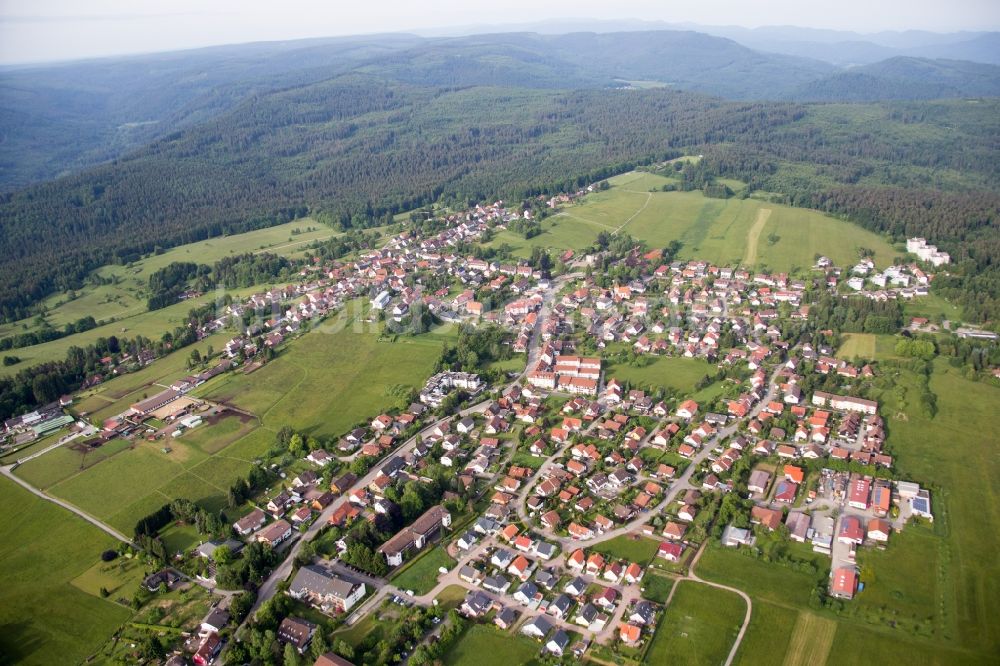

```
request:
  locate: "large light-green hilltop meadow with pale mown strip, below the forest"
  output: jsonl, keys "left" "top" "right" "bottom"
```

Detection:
{"left": 490, "top": 171, "right": 899, "bottom": 271}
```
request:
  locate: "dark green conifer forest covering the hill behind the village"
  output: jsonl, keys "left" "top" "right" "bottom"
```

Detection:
{"left": 0, "top": 62, "right": 1000, "bottom": 321}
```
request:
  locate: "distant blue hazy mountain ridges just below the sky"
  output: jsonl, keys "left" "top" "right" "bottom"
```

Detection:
{"left": 0, "top": 27, "right": 1000, "bottom": 191}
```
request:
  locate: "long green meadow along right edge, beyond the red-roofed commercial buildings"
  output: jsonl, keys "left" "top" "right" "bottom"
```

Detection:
{"left": 865, "top": 360, "right": 1000, "bottom": 655}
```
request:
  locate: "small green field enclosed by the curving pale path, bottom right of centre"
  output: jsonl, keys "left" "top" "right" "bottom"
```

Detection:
{"left": 646, "top": 581, "right": 746, "bottom": 665}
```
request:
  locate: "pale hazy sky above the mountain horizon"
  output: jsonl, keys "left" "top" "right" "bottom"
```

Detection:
{"left": 0, "top": 0, "right": 1000, "bottom": 63}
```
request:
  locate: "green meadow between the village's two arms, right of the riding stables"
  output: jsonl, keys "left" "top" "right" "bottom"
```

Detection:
{"left": 196, "top": 304, "right": 449, "bottom": 437}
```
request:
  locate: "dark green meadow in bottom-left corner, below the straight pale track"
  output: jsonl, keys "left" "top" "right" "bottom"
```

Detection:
{"left": 0, "top": 479, "right": 131, "bottom": 666}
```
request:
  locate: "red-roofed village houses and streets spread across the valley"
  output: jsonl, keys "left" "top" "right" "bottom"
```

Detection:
{"left": 5, "top": 185, "right": 947, "bottom": 664}
